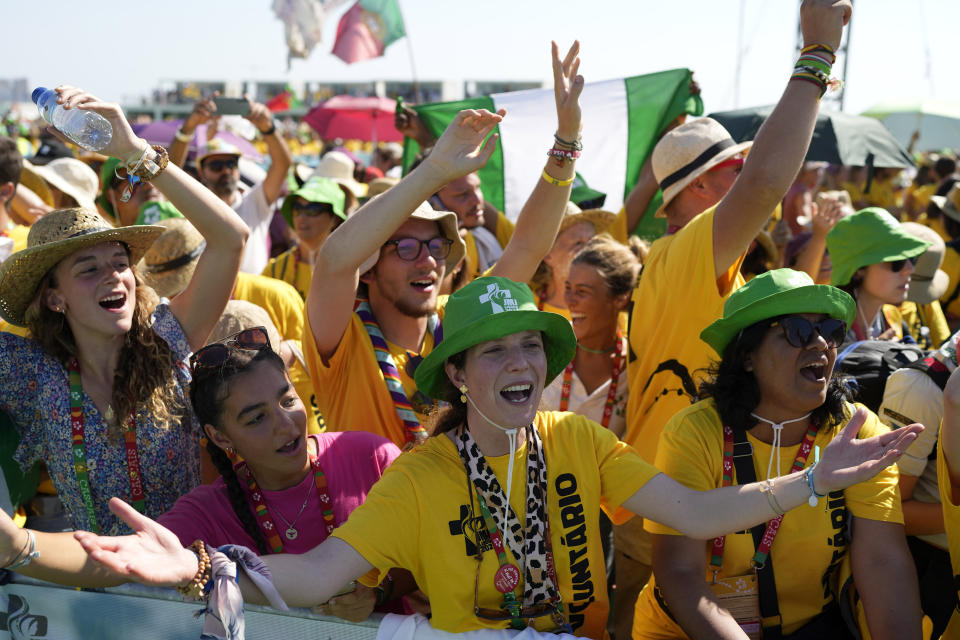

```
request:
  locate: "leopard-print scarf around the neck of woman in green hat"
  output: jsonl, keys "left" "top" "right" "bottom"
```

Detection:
{"left": 457, "top": 426, "right": 560, "bottom": 607}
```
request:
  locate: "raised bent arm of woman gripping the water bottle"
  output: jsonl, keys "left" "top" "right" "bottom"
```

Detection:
{"left": 57, "top": 86, "right": 250, "bottom": 349}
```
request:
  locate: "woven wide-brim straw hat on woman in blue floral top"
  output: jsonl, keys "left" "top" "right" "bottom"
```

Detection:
{"left": 0, "top": 207, "right": 164, "bottom": 326}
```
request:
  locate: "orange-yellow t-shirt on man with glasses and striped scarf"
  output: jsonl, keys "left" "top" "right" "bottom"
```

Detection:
{"left": 303, "top": 296, "right": 447, "bottom": 447}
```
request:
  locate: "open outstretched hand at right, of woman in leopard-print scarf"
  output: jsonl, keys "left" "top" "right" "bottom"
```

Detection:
{"left": 813, "top": 408, "right": 923, "bottom": 493}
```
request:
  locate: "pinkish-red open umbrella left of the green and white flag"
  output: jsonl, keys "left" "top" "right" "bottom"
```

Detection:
{"left": 303, "top": 96, "right": 403, "bottom": 142}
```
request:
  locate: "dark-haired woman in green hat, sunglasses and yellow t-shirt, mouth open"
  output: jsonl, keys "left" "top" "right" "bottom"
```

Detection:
{"left": 633, "top": 269, "right": 920, "bottom": 639}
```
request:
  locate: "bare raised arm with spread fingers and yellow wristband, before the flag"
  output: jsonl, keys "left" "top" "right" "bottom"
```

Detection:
{"left": 490, "top": 42, "right": 583, "bottom": 282}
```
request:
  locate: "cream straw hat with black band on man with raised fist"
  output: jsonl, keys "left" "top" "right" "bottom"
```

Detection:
{"left": 651, "top": 118, "right": 753, "bottom": 218}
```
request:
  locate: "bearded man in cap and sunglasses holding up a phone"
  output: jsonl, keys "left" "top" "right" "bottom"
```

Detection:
{"left": 169, "top": 97, "right": 293, "bottom": 274}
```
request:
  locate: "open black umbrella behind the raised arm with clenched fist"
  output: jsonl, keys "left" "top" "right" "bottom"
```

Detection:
{"left": 710, "top": 106, "right": 913, "bottom": 168}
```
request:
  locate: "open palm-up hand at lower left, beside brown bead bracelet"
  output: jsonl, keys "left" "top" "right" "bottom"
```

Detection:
{"left": 73, "top": 498, "right": 197, "bottom": 587}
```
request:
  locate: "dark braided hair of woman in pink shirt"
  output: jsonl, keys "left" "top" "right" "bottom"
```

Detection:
{"left": 190, "top": 349, "right": 286, "bottom": 555}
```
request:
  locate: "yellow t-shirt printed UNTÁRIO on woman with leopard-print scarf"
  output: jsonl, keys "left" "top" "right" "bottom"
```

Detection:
{"left": 333, "top": 412, "right": 659, "bottom": 638}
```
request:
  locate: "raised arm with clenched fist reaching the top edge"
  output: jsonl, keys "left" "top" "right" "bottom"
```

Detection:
{"left": 713, "top": 0, "right": 851, "bottom": 278}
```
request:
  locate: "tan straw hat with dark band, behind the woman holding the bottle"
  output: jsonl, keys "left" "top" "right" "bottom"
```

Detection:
{"left": 139, "top": 218, "right": 207, "bottom": 298}
